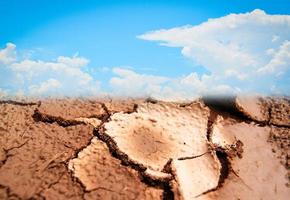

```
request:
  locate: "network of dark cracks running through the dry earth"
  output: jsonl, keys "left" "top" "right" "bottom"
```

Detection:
{"left": 0, "top": 100, "right": 289, "bottom": 199}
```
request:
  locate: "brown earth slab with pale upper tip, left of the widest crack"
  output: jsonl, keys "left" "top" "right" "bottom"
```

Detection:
{"left": 68, "top": 138, "right": 163, "bottom": 199}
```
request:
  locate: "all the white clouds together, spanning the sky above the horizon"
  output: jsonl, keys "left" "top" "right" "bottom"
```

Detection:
{"left": 0, "top": 10, "right": 290, "bottom": 100}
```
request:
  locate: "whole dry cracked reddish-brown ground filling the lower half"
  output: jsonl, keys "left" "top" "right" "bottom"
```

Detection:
{"left": 0, "top": 97, "right": 290, "bottom": 200}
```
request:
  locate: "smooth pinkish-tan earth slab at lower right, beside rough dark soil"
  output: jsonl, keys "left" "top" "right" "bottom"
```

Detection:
{"left": 202, "top": 119, "right": 290, "bottom": 200}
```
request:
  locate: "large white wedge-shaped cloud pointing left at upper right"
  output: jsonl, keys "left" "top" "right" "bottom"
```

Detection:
{"left": 138, "top": 9, "right": 290, "bottom": 93}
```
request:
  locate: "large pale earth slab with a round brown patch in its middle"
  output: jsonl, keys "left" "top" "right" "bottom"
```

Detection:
{"left": 100, "top": 102, "right": 209, "bottom": 179}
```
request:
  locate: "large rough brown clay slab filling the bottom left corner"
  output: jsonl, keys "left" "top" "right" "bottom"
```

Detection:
{"left": 0, "top": 104, "right": 93, "bottom": 199}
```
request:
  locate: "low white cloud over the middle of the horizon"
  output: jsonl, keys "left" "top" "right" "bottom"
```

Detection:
{"left": 110, "top": 67, "right": 238, "bottom": 101}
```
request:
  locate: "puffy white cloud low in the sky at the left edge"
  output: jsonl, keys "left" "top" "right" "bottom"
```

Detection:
{"left": 0, "top": 43, "right": 100, "bottom": 96}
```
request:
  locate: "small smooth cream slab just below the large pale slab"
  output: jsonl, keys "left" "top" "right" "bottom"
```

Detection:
{"left": 172, "top": 153, "right": 221, "bottom": 200}
